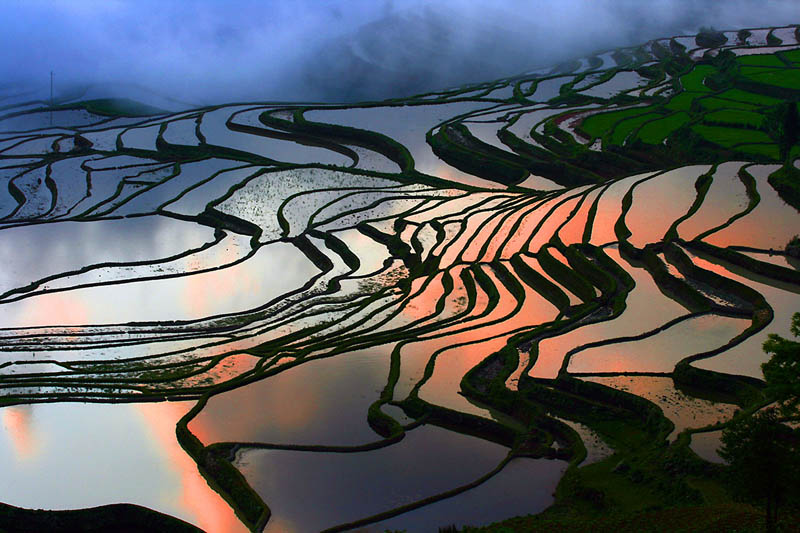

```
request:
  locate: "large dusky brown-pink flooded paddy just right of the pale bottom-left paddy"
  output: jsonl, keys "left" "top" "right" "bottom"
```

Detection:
{"left": 189, "top": 345, "right": 393, "bottom": 445}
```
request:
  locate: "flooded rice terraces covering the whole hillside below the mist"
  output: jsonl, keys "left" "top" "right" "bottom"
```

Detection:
{"left": 0, "top": 4, "right": 800, "bottom": 532}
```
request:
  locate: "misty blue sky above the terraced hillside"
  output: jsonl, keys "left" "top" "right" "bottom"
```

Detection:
{"left": 0, "top": 0, "right": 800, "bottom": 104}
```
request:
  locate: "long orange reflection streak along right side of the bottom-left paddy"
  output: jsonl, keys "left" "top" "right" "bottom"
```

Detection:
{"left": 135, "top": 403, "right": 245, "bottom": 533}
